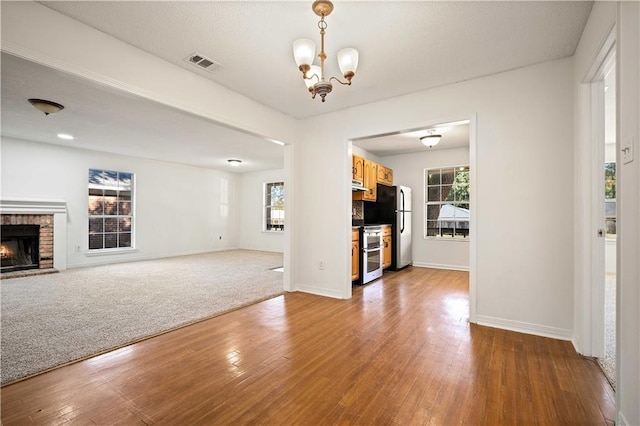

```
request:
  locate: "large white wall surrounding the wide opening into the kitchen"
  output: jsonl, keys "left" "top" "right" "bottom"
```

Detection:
{"left": 293, "top": 59, "right": 573, "bottom": 338}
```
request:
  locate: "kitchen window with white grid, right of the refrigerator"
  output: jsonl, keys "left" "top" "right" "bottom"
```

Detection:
{"left": 424, "top": 166, "right": 469, "bottom": 239}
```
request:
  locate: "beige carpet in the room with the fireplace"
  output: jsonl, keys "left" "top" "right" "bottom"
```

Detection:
{"left": 0, "top": 250, "right": 283, "bottom": 385}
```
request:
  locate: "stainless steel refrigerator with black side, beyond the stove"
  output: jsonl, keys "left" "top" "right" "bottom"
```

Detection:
{"left": 364, "top": 184, "right": 413, "bottom": 269}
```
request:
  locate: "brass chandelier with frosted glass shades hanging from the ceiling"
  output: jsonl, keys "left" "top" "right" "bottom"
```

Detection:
{"left": 293, "top": 0, "right": 358, "bottom": 102}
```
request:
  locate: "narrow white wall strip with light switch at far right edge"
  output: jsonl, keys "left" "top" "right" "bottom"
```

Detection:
{"left": 616, "top": 2, "right": 640, "bottom": 425}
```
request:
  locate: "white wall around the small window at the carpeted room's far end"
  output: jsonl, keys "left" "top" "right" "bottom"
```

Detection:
{"left": 239, "top": 170, "right": 286, "bottom": 253}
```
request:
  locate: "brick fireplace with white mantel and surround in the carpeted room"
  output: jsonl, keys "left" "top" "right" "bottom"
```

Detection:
{"left": 0, "top": 199, "right": 67, "bottom": 278}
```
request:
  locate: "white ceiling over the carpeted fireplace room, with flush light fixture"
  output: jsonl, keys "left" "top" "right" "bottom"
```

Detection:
{"left": 2, "top": 53, "right": 284, "bottom": 172}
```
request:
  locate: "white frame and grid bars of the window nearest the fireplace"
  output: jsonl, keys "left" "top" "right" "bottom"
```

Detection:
{"left": 87, "top": 169, "right": 136, "bottom": 251}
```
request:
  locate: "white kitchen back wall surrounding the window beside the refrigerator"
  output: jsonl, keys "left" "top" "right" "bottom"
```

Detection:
{"left": 382, "top": 148, "right": 469, "bottom": 270}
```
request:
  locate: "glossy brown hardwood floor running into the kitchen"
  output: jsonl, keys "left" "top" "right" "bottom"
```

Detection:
{"left": 1, "top": 267, "right": 615, "bottom": 426}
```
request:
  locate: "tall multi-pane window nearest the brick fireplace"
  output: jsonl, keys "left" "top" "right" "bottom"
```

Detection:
{"left": 89, "top": 169, "right": 133, "bottom": 250}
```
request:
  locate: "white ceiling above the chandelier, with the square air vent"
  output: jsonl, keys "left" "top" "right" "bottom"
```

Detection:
{"left": 37, "top": 1, "right": 592, "bottom": 118}
